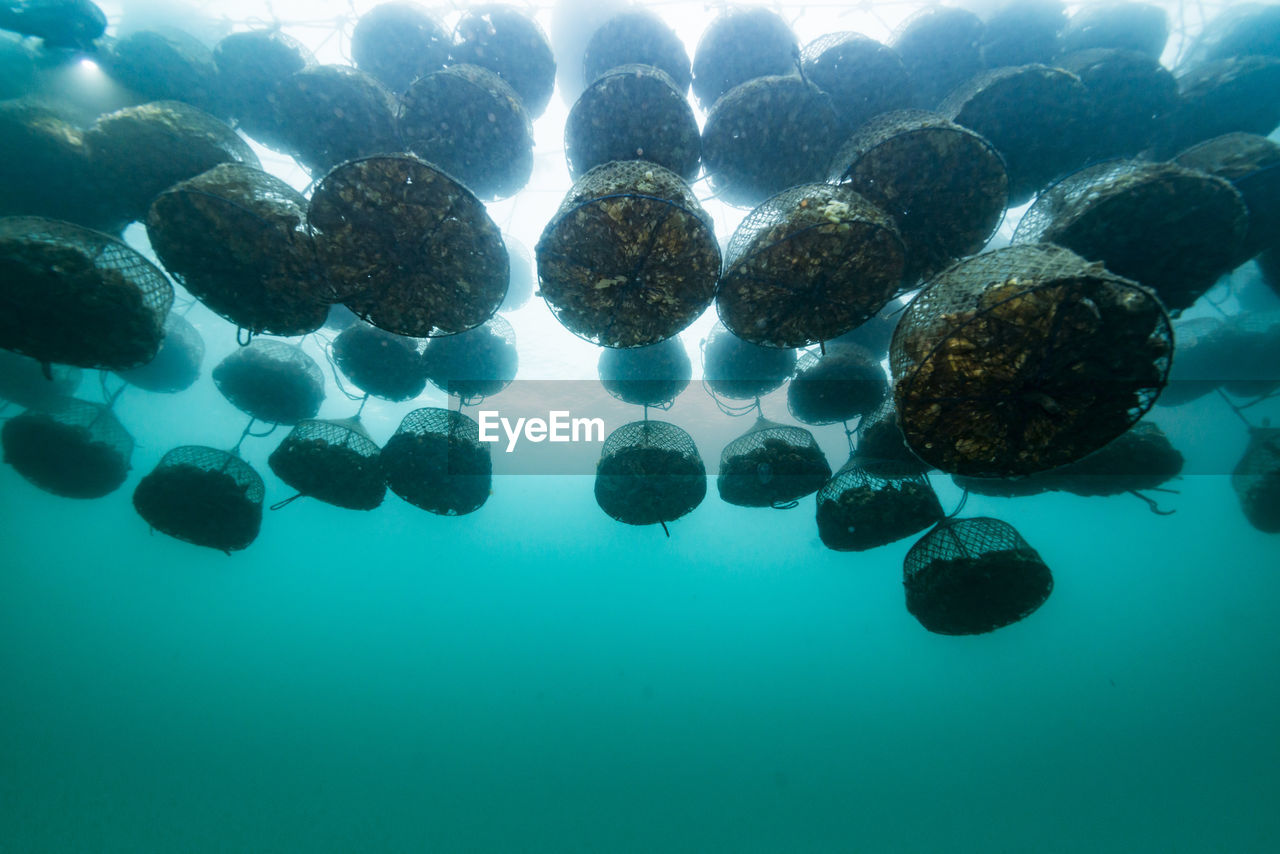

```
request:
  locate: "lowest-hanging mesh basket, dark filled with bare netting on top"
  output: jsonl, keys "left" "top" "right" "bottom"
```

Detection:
{"left": 902, "top": 516, "right": 1053, "bottom": 635}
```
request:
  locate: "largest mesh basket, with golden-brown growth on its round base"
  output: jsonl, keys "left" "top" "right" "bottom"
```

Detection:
{"left": 890, "top": 245, "right": 1172, "bottom": 478}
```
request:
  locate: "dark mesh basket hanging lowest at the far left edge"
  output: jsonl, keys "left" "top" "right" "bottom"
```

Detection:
{"left": 0, "top": 398, "right": 133, "bottom": 498}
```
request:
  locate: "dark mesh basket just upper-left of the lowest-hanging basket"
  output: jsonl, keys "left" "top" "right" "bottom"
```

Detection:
{"left": 818, "top": 458, "right": 943, "bottom": 552}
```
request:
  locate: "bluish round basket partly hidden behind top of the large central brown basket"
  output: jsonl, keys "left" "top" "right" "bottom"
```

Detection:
{"left": 564, "top": 65, "right": 701, "bottom": 181}
